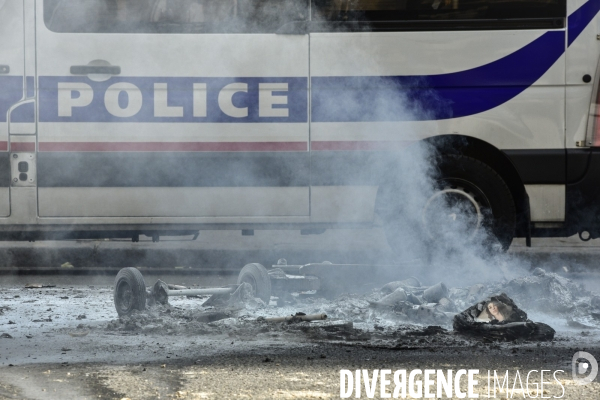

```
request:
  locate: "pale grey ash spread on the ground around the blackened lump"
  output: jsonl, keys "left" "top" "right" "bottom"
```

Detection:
{"left": 105, "top": 268, "right": 600, "bottom": 349}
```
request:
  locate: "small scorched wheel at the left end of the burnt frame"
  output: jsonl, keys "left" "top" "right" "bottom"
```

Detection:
{"left": 113, "top": 267, "right": 146, "bottom": 316}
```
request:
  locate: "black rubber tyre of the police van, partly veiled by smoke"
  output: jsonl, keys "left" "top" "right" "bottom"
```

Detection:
{"left": 378, "top": 155, "right": 517, "bottom": 250}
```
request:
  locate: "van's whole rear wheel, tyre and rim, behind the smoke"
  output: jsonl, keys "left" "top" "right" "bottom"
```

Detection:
{"left": 378, "top": 155, "right": 516, "bottom": 250}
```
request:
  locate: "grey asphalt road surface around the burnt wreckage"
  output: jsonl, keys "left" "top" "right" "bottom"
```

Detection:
{"left": 0, "top": 229, "right": 600, "bottom": 399}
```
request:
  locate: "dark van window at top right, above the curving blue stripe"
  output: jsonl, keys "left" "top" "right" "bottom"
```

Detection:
{"left": 312, "top": 0, "right": 567, "bottom": 22}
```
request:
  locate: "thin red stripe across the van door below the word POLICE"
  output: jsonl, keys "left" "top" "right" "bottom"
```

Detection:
{"left": 39, "top": 142, "right": 308, "bottom": 151}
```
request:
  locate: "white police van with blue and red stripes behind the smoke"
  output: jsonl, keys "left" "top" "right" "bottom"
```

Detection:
{"left": 0, "top": 0, "right": 600, "bottom": 248}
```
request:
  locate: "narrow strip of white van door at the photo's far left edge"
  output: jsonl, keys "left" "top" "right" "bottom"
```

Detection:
{"left": 0, "top": 0, "right": 25, "bottom": 217}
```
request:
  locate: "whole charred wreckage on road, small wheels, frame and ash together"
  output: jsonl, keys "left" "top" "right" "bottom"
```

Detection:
{"left": 106, "top": 259, "right": 600, "bottom": 342}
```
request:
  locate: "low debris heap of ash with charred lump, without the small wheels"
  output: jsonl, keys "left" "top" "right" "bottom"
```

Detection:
{"left": 106, "top": 265, "right": 600, "bottom": 347}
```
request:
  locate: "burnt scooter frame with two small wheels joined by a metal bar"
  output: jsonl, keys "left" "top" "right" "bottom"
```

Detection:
{"left": 114, "top": 259, "right": 398, "bottom": 316}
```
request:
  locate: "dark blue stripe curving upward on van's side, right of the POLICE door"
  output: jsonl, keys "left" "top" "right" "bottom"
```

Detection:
{"left": 311, "top": 31, "right": 565, "bottom": 122}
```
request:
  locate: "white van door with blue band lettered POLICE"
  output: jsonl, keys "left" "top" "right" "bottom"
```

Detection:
{"left": 37, "top": 0, "right": 309, "bottom": 222}
